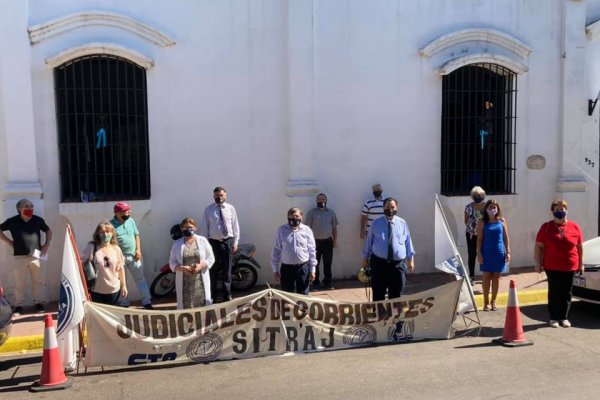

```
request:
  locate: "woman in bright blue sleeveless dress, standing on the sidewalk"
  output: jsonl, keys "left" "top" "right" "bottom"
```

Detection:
{"left": 477, "top": 199, "right": 510, "bottom": 311}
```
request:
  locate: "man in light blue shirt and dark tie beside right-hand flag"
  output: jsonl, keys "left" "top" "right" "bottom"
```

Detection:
{"left": 362, "top": 197, "right": 415, "bottom": 301}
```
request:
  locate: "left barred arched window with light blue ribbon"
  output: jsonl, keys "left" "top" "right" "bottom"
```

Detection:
{"left": 54, "top": 54, "right": 150, "bottom": 202}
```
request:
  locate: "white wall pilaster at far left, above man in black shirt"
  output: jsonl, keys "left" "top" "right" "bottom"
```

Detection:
{"left": 0, "top": 0, "right": 42, "bottom": 200}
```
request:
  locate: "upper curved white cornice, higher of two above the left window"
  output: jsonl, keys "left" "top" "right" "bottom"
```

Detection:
{"left": 27, "top": 10, "right": 175, "bottom": 47}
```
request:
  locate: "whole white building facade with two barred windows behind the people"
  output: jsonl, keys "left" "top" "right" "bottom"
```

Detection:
{"left": 0, "top": 0, "right": 600, "bottom": 299}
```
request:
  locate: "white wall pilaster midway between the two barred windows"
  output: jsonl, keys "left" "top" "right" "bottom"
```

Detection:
{"left": 287, "top": 0, "right": 319, "bottom": 197}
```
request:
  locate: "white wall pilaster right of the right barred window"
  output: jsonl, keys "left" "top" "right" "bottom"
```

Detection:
{"left": 558, "top": 0, "right": 587, "bottom": 192}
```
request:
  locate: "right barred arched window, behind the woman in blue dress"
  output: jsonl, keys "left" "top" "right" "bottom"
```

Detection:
{"left": 441, "top": 63, "right": 517, "bottom": 196}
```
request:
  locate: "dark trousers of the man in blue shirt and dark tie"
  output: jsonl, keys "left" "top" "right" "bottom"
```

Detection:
{"left": 370, "top": 254, "right": 406, "bottom": 301}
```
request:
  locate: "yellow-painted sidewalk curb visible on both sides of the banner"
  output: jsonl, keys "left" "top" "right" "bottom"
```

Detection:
{"left": 0, "top": 289, "right": 548, "bottom": 355}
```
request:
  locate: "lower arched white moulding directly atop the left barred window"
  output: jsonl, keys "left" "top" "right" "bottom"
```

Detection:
{"left": 46, "top": 43, "right": 154, "bottom": 69}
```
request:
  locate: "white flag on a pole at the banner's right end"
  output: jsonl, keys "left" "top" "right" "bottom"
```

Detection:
{"left": 435, "top": 195, "right": 475, "bottom": 314}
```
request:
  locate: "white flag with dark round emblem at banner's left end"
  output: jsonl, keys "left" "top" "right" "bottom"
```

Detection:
{"left": 56, "top": 227, "right": 86, "bottom": 368}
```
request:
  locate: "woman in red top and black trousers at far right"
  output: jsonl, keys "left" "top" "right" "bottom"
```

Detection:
{"left": 535, "top": 200, "right": 583, "bottom": 328}
